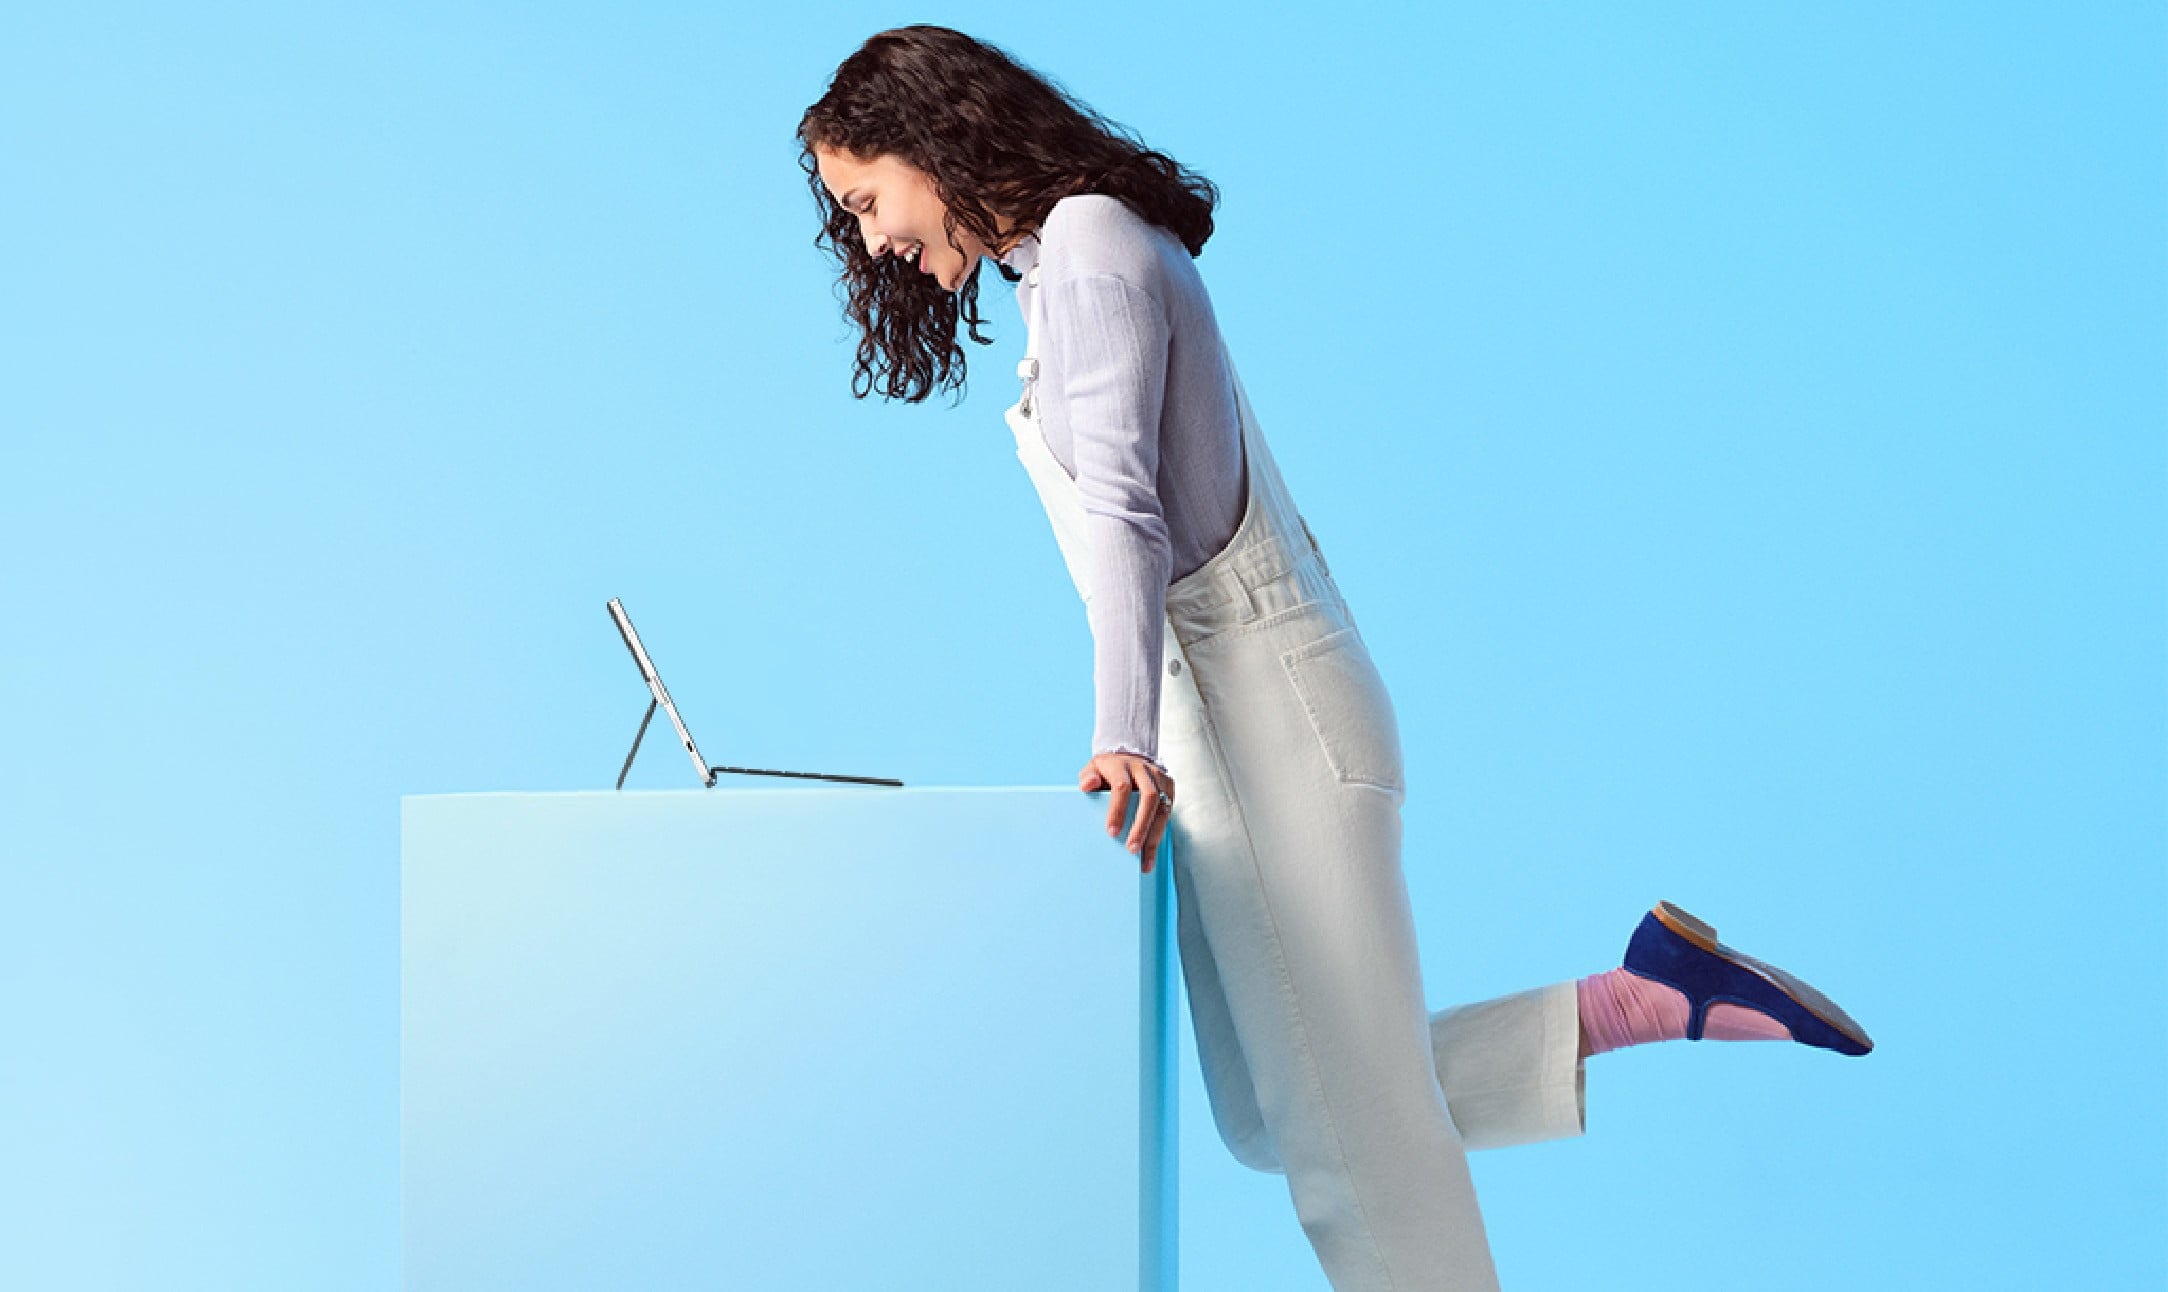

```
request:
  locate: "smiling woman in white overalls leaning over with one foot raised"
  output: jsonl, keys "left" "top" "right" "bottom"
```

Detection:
{"left": 798, "top": 26, "right": 1871, "bottom": 1292}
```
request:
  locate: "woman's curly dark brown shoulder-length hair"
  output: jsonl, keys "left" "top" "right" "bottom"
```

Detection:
{"left": 798, "top": 24, "right": 1218, "bottom": 403}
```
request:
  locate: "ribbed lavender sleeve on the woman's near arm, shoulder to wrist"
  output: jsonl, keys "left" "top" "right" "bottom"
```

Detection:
{"left": 1038, "top": 273, "right": 1173, "bottom": 761}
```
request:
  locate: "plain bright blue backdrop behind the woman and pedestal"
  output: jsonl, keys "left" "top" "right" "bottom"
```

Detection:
{"left": 0, "top": 2, "right": 2168, "bottom": 1290}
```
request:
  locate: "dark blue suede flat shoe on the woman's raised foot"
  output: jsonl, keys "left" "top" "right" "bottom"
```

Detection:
{"left": 1626, "top": 902, "right": 1875, "bottom": 1054}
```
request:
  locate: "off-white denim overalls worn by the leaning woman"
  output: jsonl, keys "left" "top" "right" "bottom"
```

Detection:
{"left": 1006, "top": 264, "right": 1583, "bottom": 1292}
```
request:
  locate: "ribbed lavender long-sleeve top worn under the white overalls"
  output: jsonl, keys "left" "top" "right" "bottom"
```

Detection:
{"left": 1002, "top": 193, "right": 1247, "bottom": 761}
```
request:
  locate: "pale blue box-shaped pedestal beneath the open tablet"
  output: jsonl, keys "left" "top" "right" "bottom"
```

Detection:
{"left": 399, "top": 787, "right": 1175, "bottom": 1292}
